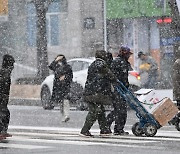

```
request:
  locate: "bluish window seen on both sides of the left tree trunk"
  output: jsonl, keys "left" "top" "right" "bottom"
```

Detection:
{"left": 27, "top": 0, "right": 60, "bottom": 47}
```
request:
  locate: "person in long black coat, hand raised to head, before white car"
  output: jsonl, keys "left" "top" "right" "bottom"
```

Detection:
{"left": 45, "top": 54, "right": 73, "bottom": 122}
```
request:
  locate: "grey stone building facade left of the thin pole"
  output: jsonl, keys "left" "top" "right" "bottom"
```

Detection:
{"left": 0, "top": 0, "right": 103, "bottom": 81}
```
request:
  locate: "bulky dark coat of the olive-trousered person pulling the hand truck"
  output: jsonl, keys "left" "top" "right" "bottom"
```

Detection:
{"left": 84, "top": 58, "right": 116, "bottom": 96}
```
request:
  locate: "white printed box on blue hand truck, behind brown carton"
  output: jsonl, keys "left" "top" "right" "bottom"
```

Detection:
{"left": 135, "top": 89, "right": 164, "bottom": 113}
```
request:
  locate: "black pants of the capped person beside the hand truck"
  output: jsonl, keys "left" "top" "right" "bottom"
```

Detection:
{"left": 107, "top": 94, "right": 127, "bottom": 133}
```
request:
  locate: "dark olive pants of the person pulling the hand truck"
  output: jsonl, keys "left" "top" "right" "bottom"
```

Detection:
{"left": 81, "top": 102, "right": 108, "bottom": 133}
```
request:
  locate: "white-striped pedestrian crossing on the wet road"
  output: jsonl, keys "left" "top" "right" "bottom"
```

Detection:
{"left": 0, "top": 126, "right": 180, "bottom": 150}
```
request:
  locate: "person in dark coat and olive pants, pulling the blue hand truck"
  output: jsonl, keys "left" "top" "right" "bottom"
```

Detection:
{"left": 80, "top": 50, "right": 116, "bottom": 137}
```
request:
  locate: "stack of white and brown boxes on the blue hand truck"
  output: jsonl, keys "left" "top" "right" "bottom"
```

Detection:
{"left": 135, "top": 89, "right": 179, "bottom": 126}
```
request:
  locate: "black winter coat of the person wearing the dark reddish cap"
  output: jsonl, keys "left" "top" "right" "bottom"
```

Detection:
{"left": 111, "top": 55, "right": 132, "bottom": 88}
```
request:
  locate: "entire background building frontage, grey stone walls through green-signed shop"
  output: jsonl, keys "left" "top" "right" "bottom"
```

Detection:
{"left": 0, "top": 0, "right": 173, "bottom": 84}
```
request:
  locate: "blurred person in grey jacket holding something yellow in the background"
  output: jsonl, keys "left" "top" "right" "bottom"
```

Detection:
{"left": 138, "top": 51, "right": 158, "bottom": 89}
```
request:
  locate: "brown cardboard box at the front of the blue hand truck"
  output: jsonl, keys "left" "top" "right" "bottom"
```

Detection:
{"left": 152, "top": 98, "right": 179, "bottom": 126}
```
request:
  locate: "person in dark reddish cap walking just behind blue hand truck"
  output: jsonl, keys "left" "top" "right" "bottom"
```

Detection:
{"left": 107, "top": 46, "right": 132, "bottom": 135}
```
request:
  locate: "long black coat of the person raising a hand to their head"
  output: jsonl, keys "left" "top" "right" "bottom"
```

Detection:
{"left": 49, "top": 61, "right": 73, "bottom": 102}
